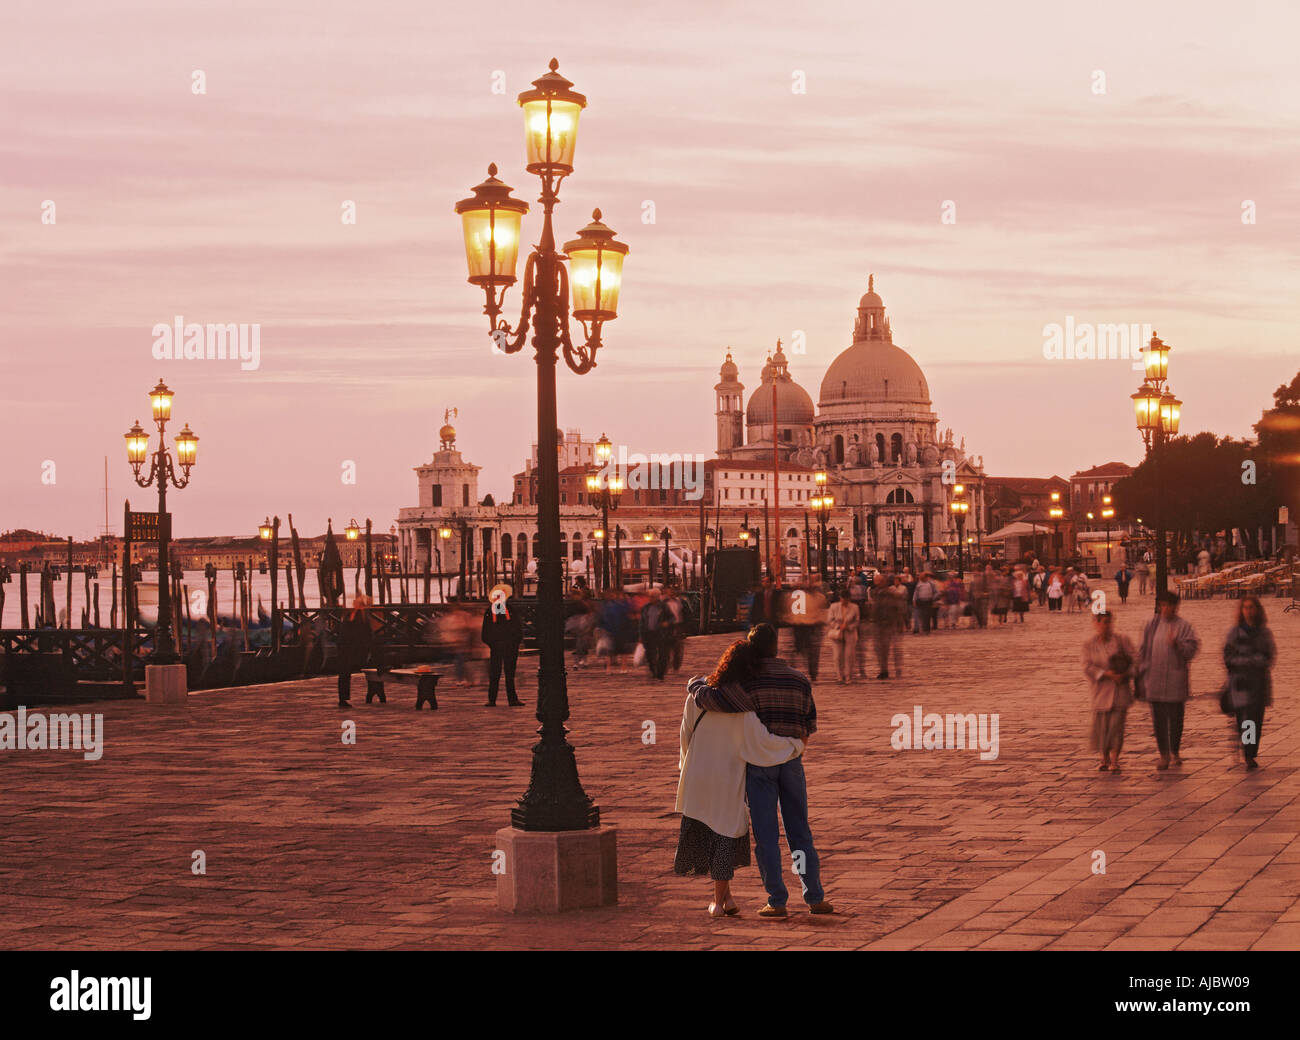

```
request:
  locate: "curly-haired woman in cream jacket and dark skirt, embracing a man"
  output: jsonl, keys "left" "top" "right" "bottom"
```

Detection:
{"left": 672, "top": 640, "right": 803, "bottom": 918}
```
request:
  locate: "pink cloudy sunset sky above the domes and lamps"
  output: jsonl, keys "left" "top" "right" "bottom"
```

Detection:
{"left": 0, "top": 0, "right": 1300, "bottom": 537}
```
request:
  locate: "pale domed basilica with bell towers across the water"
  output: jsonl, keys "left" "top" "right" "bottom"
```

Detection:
{"left": 714, "top": 276, "right": 984, "bottom": 550}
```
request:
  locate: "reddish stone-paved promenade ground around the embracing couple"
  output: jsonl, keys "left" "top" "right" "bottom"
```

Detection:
{"left": 0, "top": 592, "right": 1300, "bottom": 950}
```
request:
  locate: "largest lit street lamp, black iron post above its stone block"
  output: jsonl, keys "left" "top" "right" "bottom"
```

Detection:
{"left": 456, "top": 59, "right": 628, "bottom": 831}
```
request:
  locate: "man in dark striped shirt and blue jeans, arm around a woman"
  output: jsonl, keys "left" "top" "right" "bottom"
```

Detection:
{"left": 688, "top": 624, "right": 833, "bottom": 918}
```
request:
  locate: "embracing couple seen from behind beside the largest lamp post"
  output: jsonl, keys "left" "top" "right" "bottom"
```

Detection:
{"left": 673, "top": 624, "right": 832, "bottom": 918}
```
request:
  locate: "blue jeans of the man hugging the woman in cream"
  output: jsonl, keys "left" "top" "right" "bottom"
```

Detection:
{"left": 745, "top": 758, "right": 826, "bottom": 906}
